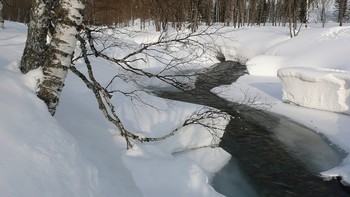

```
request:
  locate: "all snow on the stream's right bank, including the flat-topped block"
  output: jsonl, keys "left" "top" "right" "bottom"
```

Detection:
{"left": 212, "top": 23, "right": 350, "bottom": 185}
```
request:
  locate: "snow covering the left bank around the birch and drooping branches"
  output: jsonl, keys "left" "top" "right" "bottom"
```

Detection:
{"left": 0, "top": 21, "right": 231, "bottom": 197}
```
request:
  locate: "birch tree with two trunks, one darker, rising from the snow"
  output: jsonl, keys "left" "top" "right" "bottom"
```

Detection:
{"left": 20, "top": 0, "right": 84, "bottom": 115}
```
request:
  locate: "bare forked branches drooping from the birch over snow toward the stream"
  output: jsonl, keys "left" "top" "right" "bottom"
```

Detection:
{"left": 69, "top": 28, "right": 228, "bottom": 148}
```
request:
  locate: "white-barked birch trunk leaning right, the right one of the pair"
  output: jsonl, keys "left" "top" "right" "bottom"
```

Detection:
{"left": 37, "top": 0, "right": 84, "bottom": 115}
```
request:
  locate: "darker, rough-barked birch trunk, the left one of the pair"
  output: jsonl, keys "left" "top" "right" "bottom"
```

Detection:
{"left": 20, "top": 0, "right": 55, "bottom": 73}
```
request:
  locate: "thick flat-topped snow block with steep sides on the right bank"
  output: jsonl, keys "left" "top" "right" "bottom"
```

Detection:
{"left": 278, "top": 67, "right": 350, "bottom": 115}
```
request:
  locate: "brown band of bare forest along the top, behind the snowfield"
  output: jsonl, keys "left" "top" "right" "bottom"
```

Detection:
{"left": 3, "top": 0, "right": 350, "bottom": 31}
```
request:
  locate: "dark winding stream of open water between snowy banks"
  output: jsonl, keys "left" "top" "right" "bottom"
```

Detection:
{"left": 155, "top": 62, "right": 350, "bottom": 196}
